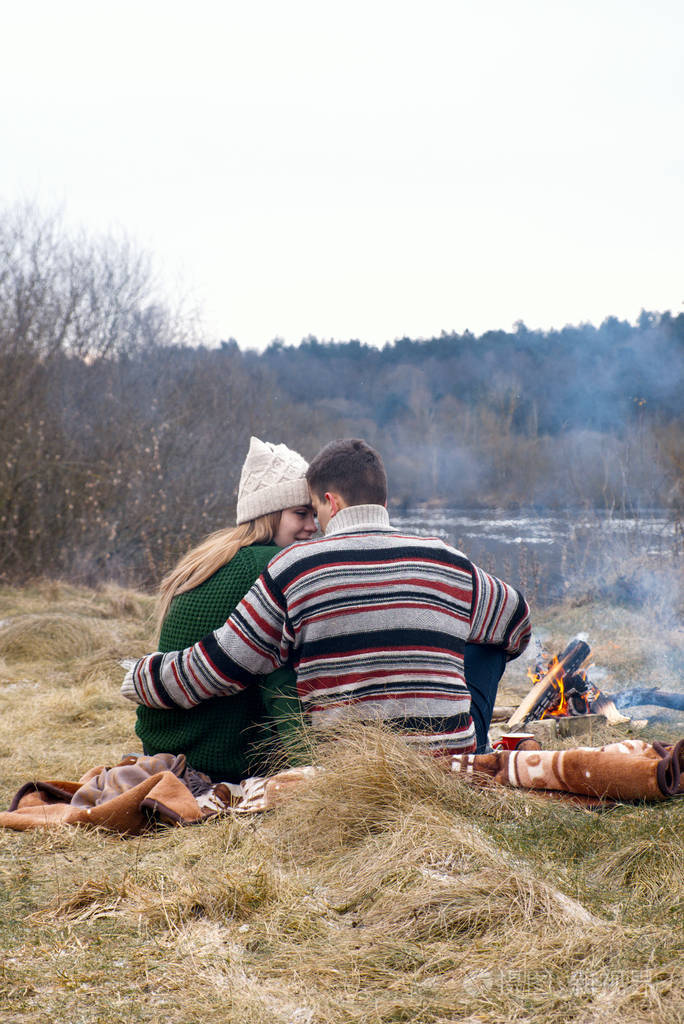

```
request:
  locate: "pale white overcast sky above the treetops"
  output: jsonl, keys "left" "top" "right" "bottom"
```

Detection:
{"left": 0, "top": 0, "right": 684, "bottom": 348}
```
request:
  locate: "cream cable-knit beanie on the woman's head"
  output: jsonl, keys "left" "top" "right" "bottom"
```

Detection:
{"left": 236, "top": 437, "right": 311, "bottom": 526}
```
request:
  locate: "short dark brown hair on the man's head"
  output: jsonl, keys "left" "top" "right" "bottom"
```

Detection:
{"left": 306, "top": 437, "right": 387, "bottom": 505}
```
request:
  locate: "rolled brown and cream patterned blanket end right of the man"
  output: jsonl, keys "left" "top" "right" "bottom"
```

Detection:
{"left": 452, "top": 739, "right": 684, "bottom": 801}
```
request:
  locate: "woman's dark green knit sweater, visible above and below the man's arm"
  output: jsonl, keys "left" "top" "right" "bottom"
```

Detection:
{"left": 135, "top": 545, "right": 300, "bottom": 782}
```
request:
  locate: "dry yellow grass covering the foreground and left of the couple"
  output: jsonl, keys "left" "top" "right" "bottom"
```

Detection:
{"left": 0, "top": 584, "right": 684, "bottom": 1024}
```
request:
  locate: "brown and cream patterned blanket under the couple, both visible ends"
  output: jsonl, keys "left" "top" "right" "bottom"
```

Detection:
{"left": 0, "top": 739, "right": 684, "bottom": 836}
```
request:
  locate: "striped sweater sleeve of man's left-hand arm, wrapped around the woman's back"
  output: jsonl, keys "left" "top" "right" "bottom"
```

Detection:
{"left": 121, "top": 571, "right": 290, "bottom": 708}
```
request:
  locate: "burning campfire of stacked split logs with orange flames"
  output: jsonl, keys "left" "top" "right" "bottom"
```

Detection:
{"left": 508, "top": 637, "right": 629, "bottom": 728}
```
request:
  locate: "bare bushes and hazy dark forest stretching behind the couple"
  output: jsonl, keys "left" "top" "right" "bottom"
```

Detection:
{"left": 0, "top": 206, "right": 684, "bottom": 587}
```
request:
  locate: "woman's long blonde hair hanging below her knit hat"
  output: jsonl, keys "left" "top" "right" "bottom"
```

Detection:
{"left": 157, "top": 511, "right": 282, "bottom": 633}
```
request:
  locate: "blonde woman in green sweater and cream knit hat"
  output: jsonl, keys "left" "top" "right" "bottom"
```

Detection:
{"left": 135, "top": 437, "right": 316, "bottom": 782}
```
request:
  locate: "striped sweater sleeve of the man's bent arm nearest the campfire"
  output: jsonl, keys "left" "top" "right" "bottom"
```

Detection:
{"left": 468, "top": 565, "right": 531, "bottom": 660}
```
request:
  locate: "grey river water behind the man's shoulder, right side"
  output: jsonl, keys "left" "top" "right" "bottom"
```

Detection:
{"left": 391, "top": 509, "right": 683, "bottom": 603}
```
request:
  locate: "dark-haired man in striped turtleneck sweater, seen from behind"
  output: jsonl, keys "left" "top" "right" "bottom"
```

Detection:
{"left": 122, "top": 439, "right": 529, "bottom": 754}
